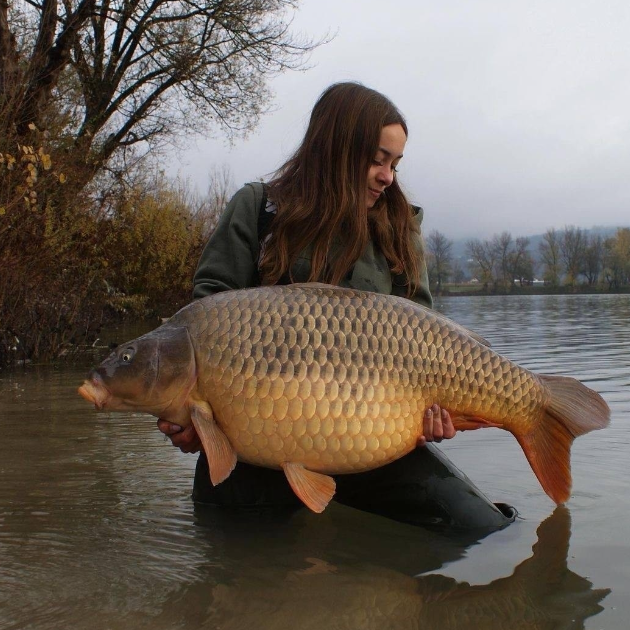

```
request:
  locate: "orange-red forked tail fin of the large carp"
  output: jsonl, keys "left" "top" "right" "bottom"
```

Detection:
{"left": 515, "top": 375, "right": 610, "bottom": 504}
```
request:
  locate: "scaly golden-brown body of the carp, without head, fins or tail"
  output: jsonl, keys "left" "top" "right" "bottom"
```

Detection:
{"left": 185, "top": 287, "right": 544, "bottom": 473}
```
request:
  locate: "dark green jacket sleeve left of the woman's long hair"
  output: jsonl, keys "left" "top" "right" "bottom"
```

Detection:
{"left": 193, "top": 183, "right": 263, "bottom": 298}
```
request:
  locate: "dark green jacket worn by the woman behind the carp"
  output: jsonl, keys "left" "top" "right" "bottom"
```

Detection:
{"left": 193, "top": 183, "right": 433, "bottom": 307}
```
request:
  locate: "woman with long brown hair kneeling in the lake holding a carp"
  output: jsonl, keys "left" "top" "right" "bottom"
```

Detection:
{"left": 158, "top": 83, "right": 512, "bottom": 532}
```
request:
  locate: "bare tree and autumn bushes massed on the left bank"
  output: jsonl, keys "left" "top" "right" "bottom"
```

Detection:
{"left": 0, "top": 0, "right": 320, "bottom": 364}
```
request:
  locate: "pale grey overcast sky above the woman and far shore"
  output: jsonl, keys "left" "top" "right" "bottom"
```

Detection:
{"left": 170, "top": 0, "right": 630, "bottom": 239}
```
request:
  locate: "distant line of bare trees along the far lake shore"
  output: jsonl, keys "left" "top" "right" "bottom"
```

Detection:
{"left": 425, "top": 226, "right": 630, "bottom": 293}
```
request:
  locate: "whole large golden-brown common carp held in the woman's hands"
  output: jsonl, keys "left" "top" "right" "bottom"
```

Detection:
{"left": 79, "top": 284, "right": 610, "bottom": 512}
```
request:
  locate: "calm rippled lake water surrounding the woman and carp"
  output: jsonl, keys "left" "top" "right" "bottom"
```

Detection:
{"left": 0, "top": 296, "right": 630, "bottom": 630}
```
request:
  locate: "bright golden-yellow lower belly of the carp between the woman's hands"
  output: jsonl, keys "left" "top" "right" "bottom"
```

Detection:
{"left": 217, "top": 379, "right": 424, "bottom": 474}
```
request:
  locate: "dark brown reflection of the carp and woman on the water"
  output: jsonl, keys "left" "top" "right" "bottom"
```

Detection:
{"left": 184, "top": 508, "right": 609, "bottom": 630}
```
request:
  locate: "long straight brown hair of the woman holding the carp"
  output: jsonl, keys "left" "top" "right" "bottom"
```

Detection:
{"left": 260, "top": 83, "right": 421, "bottom": 294}
